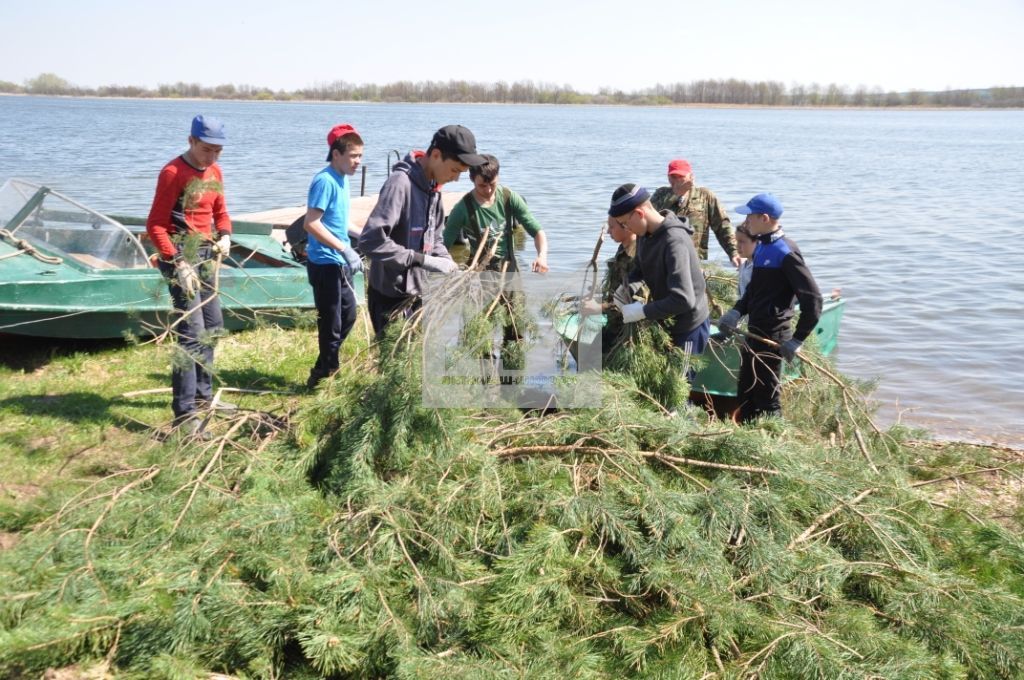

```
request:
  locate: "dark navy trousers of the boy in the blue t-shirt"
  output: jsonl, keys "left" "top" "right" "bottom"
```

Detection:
{"left": 306, "top": 262, "right": 355, "bottom": 378}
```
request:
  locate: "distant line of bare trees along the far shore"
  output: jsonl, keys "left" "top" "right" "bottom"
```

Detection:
{"left": 0, "top": 73, "right": 1024, "bottom": 108}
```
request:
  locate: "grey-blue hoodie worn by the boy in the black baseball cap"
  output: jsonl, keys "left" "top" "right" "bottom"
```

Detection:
{"left": 359, "top": 154, "right": 452, "bottom": 297}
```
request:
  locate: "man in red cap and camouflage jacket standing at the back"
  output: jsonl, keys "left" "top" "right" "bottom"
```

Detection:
{"left": 650, "top": 159, "right": 739, "bottom": 267}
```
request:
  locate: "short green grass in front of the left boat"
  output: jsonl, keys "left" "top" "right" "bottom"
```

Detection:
{"left": 0, "top": 317, "right": 376, "bottom": 547}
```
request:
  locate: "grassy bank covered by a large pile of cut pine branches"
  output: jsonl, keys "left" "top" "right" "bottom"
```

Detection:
{"left": 0, "top": 315, "right": 1024, "bottom": 678}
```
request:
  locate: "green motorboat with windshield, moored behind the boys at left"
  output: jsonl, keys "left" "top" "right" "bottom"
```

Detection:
{"left": 0, "top": 179, "right": 362, "bottom": 338}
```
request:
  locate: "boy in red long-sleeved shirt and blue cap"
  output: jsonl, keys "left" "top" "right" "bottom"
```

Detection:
{"left": 145, "top": 116, "right": 233, "bottom": 434}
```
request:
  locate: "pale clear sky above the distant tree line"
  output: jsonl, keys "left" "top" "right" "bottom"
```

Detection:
{"left": 0, "top": 0, "right": 1024, "bottom": 92}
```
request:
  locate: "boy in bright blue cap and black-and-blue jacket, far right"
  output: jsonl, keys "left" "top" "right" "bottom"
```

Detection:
{"left": 718, "top": 194, "right": 821, "bottom": 422}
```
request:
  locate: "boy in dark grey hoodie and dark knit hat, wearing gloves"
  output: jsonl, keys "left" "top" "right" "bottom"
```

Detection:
{"left": 608, "top": 184, "right": 711, "bottom": 354}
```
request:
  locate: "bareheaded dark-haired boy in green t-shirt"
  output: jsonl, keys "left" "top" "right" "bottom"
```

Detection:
{"left": 444, "top": 154, "right": 548, "bottom": 273}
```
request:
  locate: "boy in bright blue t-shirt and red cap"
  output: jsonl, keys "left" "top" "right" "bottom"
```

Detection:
{"left": 303, "top": 123, "right": 362, "bottom": 389}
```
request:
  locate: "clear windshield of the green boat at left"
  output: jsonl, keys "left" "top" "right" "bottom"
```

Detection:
{"left": 0, "top": 179, "right": 150, "bottom": 269}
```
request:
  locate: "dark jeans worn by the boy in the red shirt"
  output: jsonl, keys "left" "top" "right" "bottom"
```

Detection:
{"left": 158, "top": 246, "right": 224, "bottom": 420}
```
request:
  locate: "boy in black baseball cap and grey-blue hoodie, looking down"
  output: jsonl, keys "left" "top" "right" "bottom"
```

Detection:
{"left": 359, "top": 125, "right": 483, "bottom": 338}
